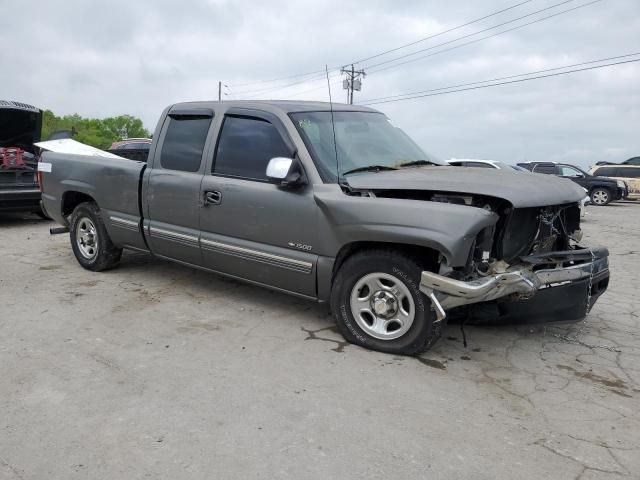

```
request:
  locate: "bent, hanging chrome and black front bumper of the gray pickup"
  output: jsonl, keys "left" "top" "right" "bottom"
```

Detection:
{"left": 420, "top": 248, "right": 609, "bottom": 321}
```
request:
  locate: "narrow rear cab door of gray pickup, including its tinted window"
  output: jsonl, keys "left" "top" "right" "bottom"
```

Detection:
{"left": 144, "top": 109, "right": 213, "bottom": 265}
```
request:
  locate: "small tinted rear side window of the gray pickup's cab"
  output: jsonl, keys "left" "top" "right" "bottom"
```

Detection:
{"left": 160, "top": 116, "right": 211, "bottom": 172}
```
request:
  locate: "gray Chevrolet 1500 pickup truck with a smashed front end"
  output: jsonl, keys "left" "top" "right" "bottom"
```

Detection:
{"left": 39, "top": 101, "right": 609, "bottom": 354}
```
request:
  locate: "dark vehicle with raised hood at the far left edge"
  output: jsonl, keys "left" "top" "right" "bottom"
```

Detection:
{"left": 0, "top": 100, "right": 43, "bottom": 216}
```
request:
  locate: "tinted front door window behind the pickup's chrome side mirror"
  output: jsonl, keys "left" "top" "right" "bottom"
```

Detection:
{"left": 213, "top": 117, "right": 291, "bottom": 180}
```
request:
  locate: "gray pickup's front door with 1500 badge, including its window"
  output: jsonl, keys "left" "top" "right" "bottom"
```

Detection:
{"left": 200, "top": 109, "right": 317, "bottom": 297}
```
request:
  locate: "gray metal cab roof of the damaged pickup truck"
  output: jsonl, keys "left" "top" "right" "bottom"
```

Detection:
{"left": 172, "top": 100, "right": 377, "bottom": 113}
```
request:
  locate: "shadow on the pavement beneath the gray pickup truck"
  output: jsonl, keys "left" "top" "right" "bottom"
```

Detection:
{"left": 108, "top": 252, "right": 576, "bottom": 370}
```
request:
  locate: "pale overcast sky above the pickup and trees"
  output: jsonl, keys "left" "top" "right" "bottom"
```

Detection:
{"left": 0, "top": 0, "right": 640, "bottom": 166}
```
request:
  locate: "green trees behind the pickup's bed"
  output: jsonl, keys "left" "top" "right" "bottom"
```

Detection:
{"left": 42, "top": 110, "right": 149, "bottom": 149}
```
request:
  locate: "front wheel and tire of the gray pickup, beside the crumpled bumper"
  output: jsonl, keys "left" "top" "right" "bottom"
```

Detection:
{"left": 331, "top": 250, "right": 442, "bottom": 355}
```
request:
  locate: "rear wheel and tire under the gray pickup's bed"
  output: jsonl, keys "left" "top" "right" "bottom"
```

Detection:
{"left": 69, "top": 202, "right": 122, "bottom": 272}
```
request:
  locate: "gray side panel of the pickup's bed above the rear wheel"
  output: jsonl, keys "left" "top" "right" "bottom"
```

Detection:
{"left": 42, "top": 152, "right": 146, "bottom": 250}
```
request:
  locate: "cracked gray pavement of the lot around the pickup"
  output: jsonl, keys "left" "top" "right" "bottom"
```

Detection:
{"left": 0, "top": 203, "right": 640, "bottom": 480}
